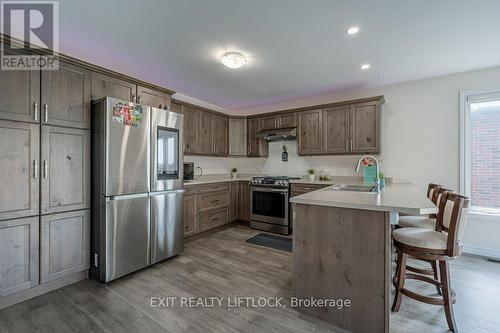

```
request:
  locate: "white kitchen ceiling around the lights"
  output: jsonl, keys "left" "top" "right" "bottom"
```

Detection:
{"left": 59, "top": 0, "right": 500, "bottom": 110}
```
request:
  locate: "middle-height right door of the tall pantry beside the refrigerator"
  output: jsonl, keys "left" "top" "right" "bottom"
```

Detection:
{"left": 41, "top": 125, "right": 90, "bottom": 214}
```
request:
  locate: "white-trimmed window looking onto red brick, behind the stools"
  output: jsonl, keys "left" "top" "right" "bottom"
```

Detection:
{"left": 460, "top": 88, "right": 500, "bottom": 215}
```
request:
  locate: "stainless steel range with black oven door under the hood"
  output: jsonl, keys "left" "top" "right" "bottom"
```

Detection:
{"left": 250, "top": 176, "right": 293, "bottom": 235}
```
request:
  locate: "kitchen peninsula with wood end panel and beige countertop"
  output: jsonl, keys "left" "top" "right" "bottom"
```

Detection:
{"left": 290, "top": 184, "right": 437, "bottom": 333}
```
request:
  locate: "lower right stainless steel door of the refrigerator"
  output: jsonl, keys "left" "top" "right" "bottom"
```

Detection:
{"left": 150, "top": 190, "right": 184, "bottom": 264}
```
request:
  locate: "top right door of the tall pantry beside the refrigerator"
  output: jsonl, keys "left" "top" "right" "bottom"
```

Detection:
{"left": 40, "top": 62, "right": 92, "bottom": 128}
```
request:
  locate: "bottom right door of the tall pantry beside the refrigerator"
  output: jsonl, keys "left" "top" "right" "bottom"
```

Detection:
{"left": 40, "top": 209, "right": 90, "bottom": 283}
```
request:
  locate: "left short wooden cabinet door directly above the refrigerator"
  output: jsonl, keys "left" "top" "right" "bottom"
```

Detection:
{"left": 92, "top": 73, "right": 137, "bottom": 102}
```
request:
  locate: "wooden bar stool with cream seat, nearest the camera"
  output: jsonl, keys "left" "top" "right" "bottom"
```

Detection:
{"left": 392, "top": 192, "right": 470, "bottom": 332}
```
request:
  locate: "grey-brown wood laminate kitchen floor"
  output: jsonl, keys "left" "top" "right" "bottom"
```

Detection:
{"left": 0, "top": 226, "right": 500, "bottom": 333}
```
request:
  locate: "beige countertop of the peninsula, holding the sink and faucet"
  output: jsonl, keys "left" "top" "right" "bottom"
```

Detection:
{"left": 290, "top": 183, "right": 438, "bottom": 215}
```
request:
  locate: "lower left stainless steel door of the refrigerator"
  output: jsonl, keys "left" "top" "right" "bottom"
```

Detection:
{"left": 100, "top": 193, "right": 151, "bottom": 282}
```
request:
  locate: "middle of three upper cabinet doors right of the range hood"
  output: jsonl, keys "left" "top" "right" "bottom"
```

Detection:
{"left": 323, "top": 105, "right": 350, "bottom": 154}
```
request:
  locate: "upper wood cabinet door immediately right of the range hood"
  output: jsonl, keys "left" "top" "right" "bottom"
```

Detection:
{"left": 298, "top": 109, "right": 323, "bottom": 155}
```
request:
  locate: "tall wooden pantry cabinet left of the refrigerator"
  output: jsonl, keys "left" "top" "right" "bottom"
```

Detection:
{"left": 0, "top": 58, "right": 92, "bottom": 300}
